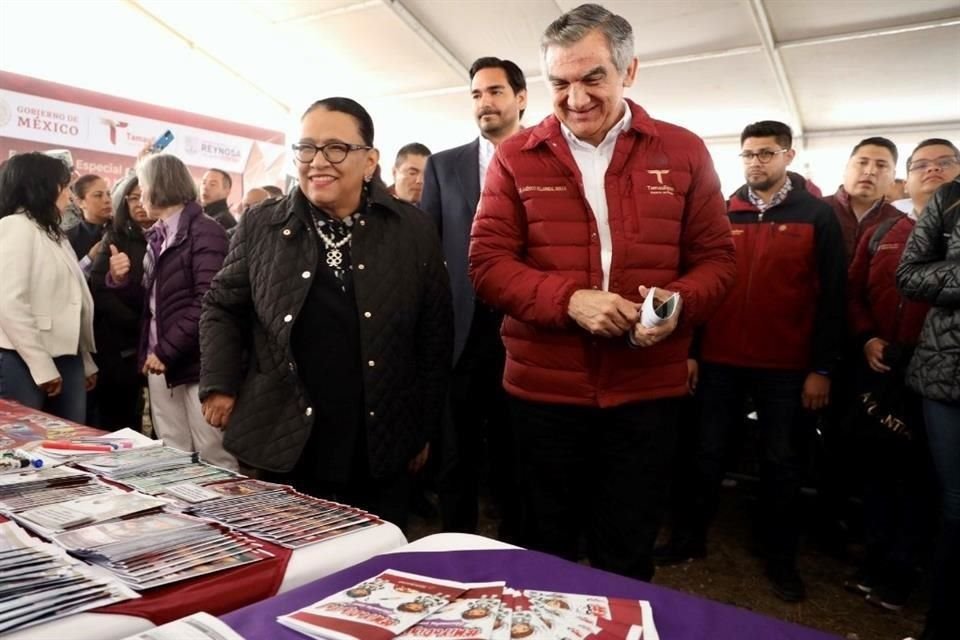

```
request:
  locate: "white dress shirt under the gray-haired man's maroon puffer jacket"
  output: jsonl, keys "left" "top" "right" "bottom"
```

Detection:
{"left": 560, "top": 102, "right": 633, "bottom": 291}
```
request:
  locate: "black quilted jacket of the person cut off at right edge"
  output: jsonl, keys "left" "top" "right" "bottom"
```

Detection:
{"left": 897, "top": 179, "right": 960, "bottom": 404}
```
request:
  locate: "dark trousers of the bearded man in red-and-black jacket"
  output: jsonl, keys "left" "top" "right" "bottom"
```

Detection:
{"left": 680, "top": 363, "right": 806, "bottom": 565}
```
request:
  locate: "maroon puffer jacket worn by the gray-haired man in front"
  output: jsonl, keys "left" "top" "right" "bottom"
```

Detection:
{"left": 470, "top": 101, "right": 736, "bottom": 407}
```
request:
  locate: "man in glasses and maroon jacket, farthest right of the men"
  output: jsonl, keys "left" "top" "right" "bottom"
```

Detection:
{"left": 846, "top": 138, "right": 960, "bottom": 611}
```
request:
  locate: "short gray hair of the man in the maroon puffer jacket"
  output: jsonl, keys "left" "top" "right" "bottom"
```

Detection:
{"left": 540, "top": 4, "right": 633, "bottom": 73}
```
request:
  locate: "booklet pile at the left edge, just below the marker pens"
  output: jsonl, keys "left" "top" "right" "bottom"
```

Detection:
{"left": 0, "top": 467, "right": 111, "bottom": 513}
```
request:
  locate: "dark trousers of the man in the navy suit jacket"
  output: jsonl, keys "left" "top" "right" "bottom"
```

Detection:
{"left": 440, "top": 302, "right": 520, "bottom": 541}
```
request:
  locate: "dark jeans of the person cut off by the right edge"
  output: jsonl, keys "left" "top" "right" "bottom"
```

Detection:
{"left": 923, "top": 398, "right": 960, "bottom": 640}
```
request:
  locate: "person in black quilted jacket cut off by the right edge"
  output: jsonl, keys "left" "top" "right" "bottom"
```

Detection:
{"left": 897, "top": 175, "right": 960, "bottom": 640}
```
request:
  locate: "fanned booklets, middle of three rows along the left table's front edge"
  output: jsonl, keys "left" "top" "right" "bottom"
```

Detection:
{"left": 53, "top": 513, "right": 273, "bottom": 591}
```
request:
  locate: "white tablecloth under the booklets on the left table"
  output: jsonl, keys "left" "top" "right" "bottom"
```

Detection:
{"left": 3, "top": 522, "right": 404, "bottom": 640}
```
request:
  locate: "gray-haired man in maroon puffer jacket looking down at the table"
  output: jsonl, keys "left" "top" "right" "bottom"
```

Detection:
{"left": 470, "top": 4, "right": 736, "bottom": 580}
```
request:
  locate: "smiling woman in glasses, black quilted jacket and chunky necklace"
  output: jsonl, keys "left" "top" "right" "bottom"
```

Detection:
{"left": 200, "top": 97, "right": 453, "bottom": 528}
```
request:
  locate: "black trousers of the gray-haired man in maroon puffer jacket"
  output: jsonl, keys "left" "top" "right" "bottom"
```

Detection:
{"left": 510, "top": 398, "right": 680, "bottom": 580}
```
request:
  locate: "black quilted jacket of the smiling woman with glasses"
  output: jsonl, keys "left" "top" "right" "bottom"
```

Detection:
{"left": 200, "top": 182, "right": 453, "bottom": 477}
